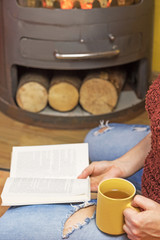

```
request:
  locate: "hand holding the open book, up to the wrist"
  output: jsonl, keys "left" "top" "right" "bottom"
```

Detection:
{"left": 78, "top": 160, "right": 124, "bottom": 191}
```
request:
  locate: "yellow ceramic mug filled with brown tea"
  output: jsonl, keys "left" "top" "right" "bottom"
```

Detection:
{"left": 96, "top": 178, "right": 137, "bottom": 235}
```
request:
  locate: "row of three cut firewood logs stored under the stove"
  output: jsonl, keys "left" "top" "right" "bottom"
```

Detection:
{"left": 16, "top": 69, "right": 126, "bottom": 115}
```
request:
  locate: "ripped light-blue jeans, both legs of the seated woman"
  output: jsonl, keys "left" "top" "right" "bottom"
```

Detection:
{"left": 0, "top": 122, "right": 150, "bottom": 240}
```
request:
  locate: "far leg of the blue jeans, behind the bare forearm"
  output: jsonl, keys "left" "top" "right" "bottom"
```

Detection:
{"left": 84, "top": 123, "right": 150, "bottom": 190}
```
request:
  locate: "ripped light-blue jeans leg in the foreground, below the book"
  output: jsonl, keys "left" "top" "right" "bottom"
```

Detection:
{"left": 0, "top": 200, "right": 128, "bottom": 240}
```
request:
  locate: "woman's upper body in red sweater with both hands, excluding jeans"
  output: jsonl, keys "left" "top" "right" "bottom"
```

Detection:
{"left": 79, "top": 76, "right": 160, "bottom": 240}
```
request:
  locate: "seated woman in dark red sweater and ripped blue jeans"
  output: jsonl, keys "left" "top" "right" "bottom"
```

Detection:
{"left": 0, "top": 77, "right": 160, "bottom": 240}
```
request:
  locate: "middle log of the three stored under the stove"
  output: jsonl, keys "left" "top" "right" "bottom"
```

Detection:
{"left": 48, "top": 74, "right": 81, "bottom": 112}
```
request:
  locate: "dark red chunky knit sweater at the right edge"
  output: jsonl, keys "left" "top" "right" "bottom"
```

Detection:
{"left": 142, "top": 76, "right": 160, "bottom": 203}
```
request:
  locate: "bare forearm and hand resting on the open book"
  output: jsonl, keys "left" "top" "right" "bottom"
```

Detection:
{"left": 78, "top": 133, "right": 151, "bottom": 191}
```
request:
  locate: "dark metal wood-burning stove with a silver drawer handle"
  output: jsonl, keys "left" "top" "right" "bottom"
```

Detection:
{"left": 0, "top": 0, "right": 154, "bottom": 128}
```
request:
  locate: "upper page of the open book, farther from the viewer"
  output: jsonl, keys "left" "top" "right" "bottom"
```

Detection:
{"left": 10, "top": 143, "right": 89, "bottom": 178}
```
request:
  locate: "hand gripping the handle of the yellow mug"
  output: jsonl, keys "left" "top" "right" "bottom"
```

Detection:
{"left": 123, "top": 195, "right": 160, "bottom": 240}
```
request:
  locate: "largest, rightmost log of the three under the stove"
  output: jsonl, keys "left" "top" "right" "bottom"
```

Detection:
{"left": 80, "top": 71, "right": 125, "bottom": 115}
